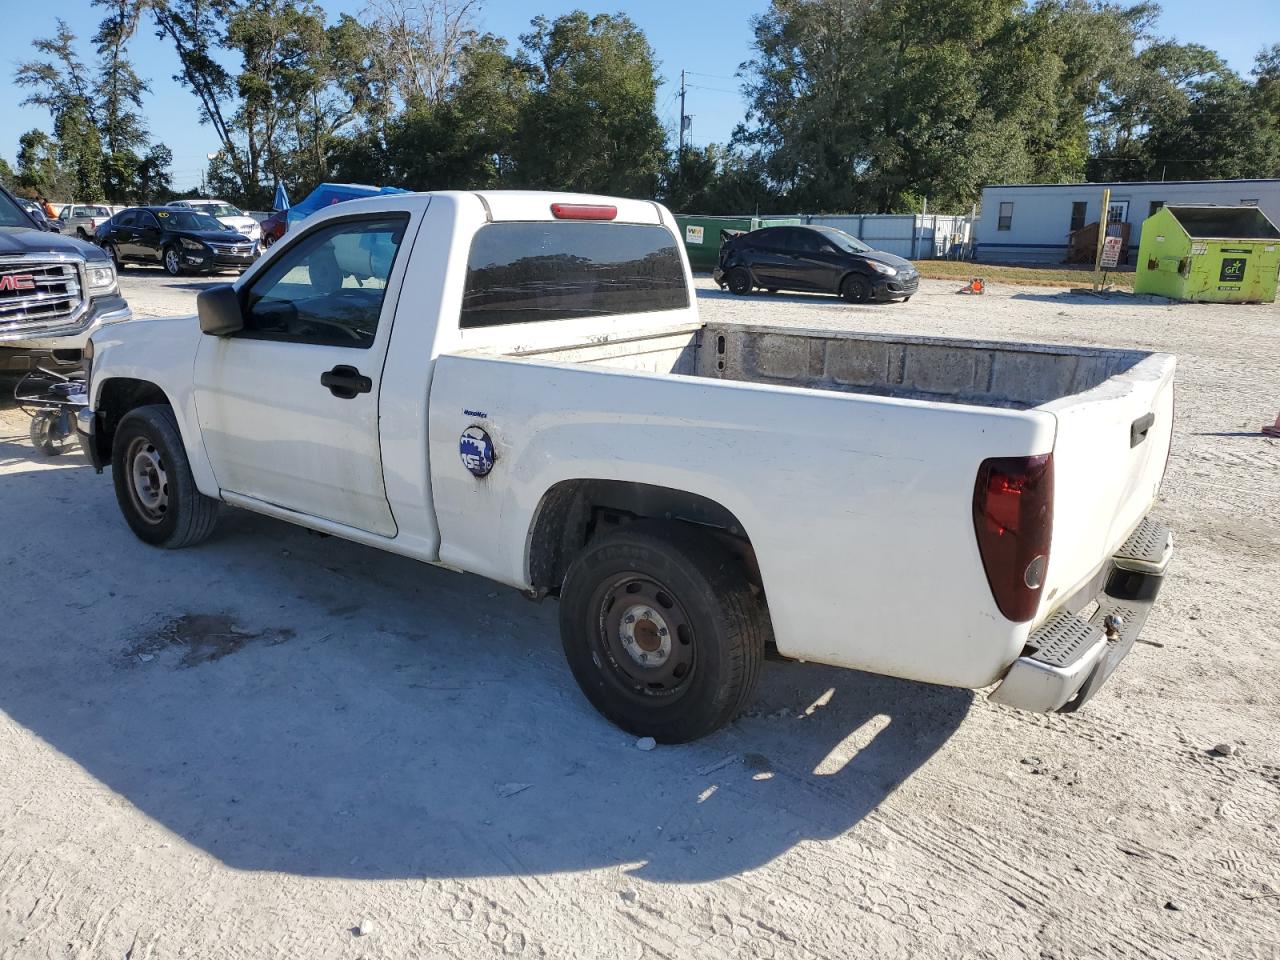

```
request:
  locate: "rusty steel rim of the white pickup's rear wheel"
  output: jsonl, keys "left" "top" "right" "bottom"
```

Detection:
{"left": 589, "top": 572, "right": 698, "bottom": 703}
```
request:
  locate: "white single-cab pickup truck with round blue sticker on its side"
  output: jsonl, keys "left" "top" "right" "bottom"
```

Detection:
{"left": 79, "top": 192, "right": 1174, "bottom": 742}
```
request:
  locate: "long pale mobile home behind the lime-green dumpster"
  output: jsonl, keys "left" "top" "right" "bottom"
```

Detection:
{"left": 974, "top": 179, "right": 1280, "bottom": 264}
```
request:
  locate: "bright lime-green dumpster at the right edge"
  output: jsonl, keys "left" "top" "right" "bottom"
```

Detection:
{"left": 1133, "top": 206, "right": 1280, "bottom": 303}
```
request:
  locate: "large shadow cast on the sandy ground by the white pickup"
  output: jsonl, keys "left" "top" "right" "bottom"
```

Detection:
{"left": 0, "top": 455, "right": 973, "bottom": 882}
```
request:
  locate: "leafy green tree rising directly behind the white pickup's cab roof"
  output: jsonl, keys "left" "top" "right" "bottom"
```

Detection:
{"left": 513, "top": 10, "right": 664, "bottom": 197}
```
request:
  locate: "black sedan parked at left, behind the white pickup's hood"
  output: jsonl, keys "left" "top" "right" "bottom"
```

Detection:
{"left": 93, "top": 206, "right": 257, "bottom": 276}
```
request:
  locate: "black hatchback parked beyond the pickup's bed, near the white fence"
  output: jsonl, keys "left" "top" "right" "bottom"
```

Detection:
{"left": 712, "top": 227, "right": 920, "bottom": 303}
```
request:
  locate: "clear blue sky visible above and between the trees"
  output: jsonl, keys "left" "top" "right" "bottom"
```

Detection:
{"left": 0, "top": 0, "right": 1280, "bottom": 189}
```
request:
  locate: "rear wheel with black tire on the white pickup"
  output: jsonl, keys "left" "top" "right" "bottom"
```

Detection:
{"left": 561, "top": 524, "right": 771, "bottom": 744}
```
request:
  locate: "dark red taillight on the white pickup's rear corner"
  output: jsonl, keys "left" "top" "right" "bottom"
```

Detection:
{"left": 973, "top": 453, "right": 1053, "bottom": 623}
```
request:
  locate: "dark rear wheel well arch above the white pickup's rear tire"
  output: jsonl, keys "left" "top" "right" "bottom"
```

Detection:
{"left": 529, "top": 480, "right": 763, "bottom": 595}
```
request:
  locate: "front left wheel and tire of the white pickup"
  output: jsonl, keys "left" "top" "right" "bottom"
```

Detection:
{"left": 111, "top": 404, "right": 219, "bottom": 549}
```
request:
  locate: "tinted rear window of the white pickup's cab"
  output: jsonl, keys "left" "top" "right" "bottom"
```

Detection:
{"left": 460, "top": 220, "right": 689, "bottom": 329}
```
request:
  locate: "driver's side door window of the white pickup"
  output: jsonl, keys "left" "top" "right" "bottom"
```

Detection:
{"left": 237, "top": 214, "right": 408, "bottom": 349}
